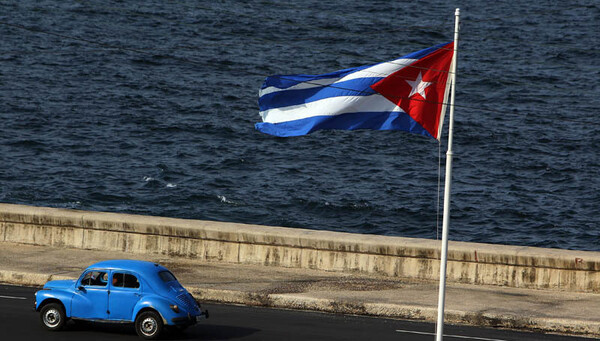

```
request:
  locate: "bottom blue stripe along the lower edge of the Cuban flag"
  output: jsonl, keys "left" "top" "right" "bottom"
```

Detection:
{"left": 255, "top": 111, "right": 432, "bottom": 137}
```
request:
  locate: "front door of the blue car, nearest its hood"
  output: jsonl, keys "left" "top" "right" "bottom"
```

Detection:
{"left": 71, "top": 269, "right": 110, "bottom": 320}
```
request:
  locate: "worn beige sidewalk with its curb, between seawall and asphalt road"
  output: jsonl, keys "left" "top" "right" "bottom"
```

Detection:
{"left": 0, "top": 243, "right": 600, "bottom": 336}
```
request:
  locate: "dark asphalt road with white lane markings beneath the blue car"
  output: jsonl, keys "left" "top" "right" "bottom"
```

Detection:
{"left": 0, "top": 285, "right": 590, "bottom": 341}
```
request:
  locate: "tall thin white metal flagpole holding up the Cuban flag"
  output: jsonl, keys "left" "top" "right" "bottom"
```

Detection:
{"left": 435, "top": 8, "right": 460, "bottom": 341}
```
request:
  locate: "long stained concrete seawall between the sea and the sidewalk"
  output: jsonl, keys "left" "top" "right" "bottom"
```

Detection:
{"left": 0, "top": 204, "right": 600, "bottom": 293}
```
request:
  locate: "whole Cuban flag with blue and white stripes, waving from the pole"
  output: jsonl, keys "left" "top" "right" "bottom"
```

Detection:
{"left": 256, "top": 43, "right": 454, "bottom": 140}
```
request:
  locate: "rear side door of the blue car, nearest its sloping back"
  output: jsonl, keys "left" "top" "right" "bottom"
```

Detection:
{"left": 108, "top": 271, "right": 143, "bottom": 321}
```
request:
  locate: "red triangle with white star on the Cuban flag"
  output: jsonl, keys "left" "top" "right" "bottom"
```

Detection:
{"left": 371, "top": 43, "right": 454, "bottom": 139}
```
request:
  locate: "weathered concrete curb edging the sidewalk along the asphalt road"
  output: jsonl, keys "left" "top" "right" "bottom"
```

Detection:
{"left": 0, "top": 270, "right": 600, "bottom": 337}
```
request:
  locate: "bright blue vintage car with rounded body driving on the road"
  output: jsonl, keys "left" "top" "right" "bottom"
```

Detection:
{"left": 35, "top": 260, "right": 208, "bottom": 339}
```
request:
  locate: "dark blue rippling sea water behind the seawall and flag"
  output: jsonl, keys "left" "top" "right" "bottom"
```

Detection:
{"left": 0, "top": 0, "right": 600, "bottom": 250}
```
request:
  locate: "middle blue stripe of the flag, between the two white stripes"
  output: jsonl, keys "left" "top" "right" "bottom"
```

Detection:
{"left": 258, "top": 77, "right": 383, "bottom": 111}
